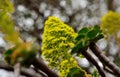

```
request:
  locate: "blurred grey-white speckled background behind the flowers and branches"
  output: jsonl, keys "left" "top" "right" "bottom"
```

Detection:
{"left": 0, "top": 0, "right": 120, "bottom": 77}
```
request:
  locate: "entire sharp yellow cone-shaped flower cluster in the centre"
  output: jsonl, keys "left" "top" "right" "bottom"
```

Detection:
{"left": 42, "top": 16, "right": 81, "bottom": 77}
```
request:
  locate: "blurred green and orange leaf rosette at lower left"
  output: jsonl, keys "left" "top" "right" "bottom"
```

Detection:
{"left": 4, "top": 42, "right": 36, "bottom": 66}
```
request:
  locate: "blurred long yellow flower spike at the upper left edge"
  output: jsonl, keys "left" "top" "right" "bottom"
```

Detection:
{"left": 0, "top": 0, "right": 19, "bottom": 44}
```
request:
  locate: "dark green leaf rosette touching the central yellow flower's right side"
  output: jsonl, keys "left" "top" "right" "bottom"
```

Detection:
{"left": 71, "top": 25, "right": 103, "bottom": 54}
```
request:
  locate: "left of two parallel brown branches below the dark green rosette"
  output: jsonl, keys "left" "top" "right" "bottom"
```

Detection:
{"left": 81, "top": 51, "right": 106, "bottom": 77}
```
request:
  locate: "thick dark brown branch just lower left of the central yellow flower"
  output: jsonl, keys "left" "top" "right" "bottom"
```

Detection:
{"left": 32, "top": 58, "right": 59, "bottom": 77}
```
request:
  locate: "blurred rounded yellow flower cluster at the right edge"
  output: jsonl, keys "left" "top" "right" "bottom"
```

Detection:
{"left": 101, "top": 11, "right": 120, "bottom": 34}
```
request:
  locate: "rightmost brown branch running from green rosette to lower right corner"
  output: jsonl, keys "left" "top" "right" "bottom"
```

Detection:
{"left": 90, "top": 43, "right": 120, "bottom": 77}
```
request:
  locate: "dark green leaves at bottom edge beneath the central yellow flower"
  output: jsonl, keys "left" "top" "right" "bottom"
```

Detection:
{"left": 67, "top": 68, "right": 86, "bottom": 77}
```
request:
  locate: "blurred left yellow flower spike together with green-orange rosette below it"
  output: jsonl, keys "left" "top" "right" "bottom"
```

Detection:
{"left": 0, "top": 0, "right": 36, "bottom": 66}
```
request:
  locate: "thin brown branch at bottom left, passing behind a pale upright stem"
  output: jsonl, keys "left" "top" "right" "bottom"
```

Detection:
{"left": 0, "top": 61, "right": 45, "bottom": 77}
